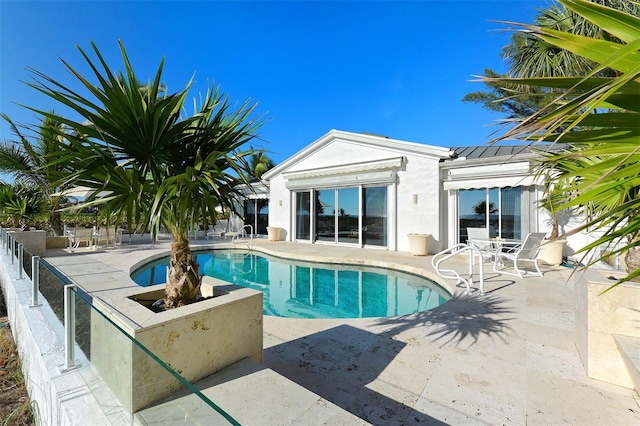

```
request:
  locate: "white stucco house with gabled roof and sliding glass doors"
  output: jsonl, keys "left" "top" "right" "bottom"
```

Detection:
{"left": 238, "top": 130, "right": 587, "bottom": 254}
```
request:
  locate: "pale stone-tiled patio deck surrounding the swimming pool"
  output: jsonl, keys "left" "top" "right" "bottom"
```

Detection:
{"left": 22, "top": 240, "right": 640, "bottom": 425}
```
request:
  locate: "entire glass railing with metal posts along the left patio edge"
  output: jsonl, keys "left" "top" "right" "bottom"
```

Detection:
{"left": 0, "top": 229, "right": 239, "bottom": 425}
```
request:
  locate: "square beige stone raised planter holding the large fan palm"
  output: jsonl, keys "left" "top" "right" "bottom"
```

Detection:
{"left": 91, "top": 277, "right": 263, "bottom": 413}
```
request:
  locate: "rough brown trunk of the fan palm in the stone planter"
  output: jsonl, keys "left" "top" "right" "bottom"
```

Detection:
{"left": 164, "top": 240, "right": 202, "bottom": 309}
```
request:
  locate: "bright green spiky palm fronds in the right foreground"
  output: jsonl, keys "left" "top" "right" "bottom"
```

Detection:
{"left": 490, "top": 0, "right": 640, "bottom": 282}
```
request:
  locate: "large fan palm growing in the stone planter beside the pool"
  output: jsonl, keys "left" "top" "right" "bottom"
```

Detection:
{"left": 29, "top": 43, "right": 263, "bottom": 309}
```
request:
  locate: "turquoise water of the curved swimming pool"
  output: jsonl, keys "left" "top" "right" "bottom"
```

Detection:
{"left": 131, "top": 250, "right": 451, "bottom": 318}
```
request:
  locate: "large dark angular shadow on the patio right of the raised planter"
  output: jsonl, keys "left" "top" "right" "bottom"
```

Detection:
{"left": 263, "top": 325, "right": 445, "bottom": 425}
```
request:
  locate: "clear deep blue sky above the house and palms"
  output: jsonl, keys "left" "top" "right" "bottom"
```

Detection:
{"left": 0, "top": 0, "right": 550, "bottom": 163}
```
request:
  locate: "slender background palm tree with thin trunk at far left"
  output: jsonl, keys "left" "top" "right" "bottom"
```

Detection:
{"left": 0, "top": 112, "right": 68, "bottom": 235}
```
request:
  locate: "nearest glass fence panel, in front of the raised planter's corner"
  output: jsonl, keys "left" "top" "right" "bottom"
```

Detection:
{"left": 73, "top": 288, "right": 238, "bottom": 424}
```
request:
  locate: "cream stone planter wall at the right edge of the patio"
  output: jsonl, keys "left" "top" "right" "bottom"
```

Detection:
{"left": 574, "top": 269, "right": 640, "bottom": 389}
